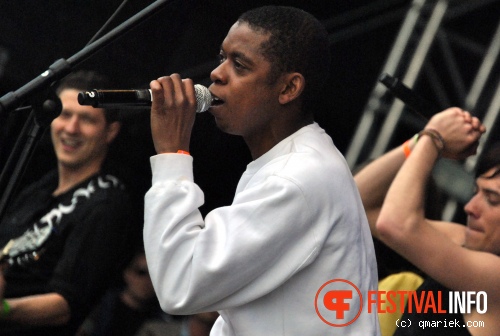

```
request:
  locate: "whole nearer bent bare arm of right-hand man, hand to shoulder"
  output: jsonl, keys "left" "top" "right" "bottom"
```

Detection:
{"left": 376, "top": 108, "right": 498, "bottom": 290}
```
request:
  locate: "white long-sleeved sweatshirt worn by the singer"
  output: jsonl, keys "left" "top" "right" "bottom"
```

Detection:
{"left": 144, "top": 123, "right": 380, "bottom": 336}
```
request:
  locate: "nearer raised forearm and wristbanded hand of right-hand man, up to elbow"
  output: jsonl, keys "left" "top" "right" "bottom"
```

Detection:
{"left": 377, "top": 108, "right": 485, "bottom": 239}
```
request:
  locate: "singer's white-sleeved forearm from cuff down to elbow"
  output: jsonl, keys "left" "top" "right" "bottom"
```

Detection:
{"left": 143, "top": 154, "right": 204, "bottom": 314}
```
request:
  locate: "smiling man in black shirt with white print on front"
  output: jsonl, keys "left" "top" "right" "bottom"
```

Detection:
{"left": 0, "top": 72, "right": 138, "bottom": 336}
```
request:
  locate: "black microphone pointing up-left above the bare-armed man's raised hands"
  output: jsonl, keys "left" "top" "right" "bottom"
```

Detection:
{"left": 379, "top": 73, "right": 441, "bottom": 120}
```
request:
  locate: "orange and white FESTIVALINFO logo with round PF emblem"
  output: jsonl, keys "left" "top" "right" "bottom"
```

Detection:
{"left": 315, "top": 279, "right": 488, "bottom": 327}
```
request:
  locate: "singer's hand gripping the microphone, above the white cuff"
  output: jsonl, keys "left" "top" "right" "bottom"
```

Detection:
{"left": 150, "top": 74, "right": 196, "bottom": 154}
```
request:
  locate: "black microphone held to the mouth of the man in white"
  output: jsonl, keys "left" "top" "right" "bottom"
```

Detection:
{"left": 78, "top": 84, "right": 213, "bottom": 112}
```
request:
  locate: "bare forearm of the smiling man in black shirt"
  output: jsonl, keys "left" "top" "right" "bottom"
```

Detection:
{"left": 2, "top": 293, "right": 71, "bottom": 326}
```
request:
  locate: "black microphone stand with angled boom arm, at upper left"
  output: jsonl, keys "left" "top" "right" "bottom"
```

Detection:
{"left": 0, "top": 0, "right": 173, "bottom": 220}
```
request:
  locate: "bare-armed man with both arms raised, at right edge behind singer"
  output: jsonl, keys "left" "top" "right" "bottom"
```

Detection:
{"left": 355, "top": 107, "right": 500, "bottom": 336}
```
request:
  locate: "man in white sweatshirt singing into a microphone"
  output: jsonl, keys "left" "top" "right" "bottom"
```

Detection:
{"left": 144, "top": 6, "right": 379, "bottom": 336}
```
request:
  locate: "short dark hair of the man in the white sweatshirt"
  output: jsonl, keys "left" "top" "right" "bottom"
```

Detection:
{"left": 238, "top": 6, "right": 330, "bottom": 100}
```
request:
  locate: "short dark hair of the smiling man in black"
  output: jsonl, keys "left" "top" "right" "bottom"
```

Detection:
{"left": 56, "top": 70, "right": 119, "bottom": 123}
